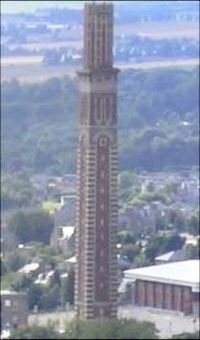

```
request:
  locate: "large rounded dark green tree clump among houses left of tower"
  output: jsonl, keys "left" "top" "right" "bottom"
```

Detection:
{"left": 8, "top": 210, "right": 53, "bottom": 244}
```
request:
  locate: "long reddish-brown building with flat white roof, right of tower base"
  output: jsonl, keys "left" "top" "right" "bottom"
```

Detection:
{"left": 119, "top": 260, "right": 200, "bottom": 317}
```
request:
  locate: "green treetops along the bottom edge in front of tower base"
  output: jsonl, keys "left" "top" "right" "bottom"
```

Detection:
{"left": 11, "top": 319, "right": 199, "bottom": 340}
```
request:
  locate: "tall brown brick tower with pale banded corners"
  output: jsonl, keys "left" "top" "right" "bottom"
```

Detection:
{"left": 75, "top": 3, "right": 119, "bottom": 319}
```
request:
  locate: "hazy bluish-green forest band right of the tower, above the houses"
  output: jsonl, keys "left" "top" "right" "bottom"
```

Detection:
{"left": 119, "top": 69, "right": 199, "bottom": 170}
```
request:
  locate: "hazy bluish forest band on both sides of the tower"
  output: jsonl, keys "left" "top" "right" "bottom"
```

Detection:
{"left": 1, "top": 68, "right": 199, "bottom": 174}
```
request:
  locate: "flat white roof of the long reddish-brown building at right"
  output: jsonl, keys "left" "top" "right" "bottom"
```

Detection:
{"left": 124, "top": 260, "right": 200, "bottom": 292}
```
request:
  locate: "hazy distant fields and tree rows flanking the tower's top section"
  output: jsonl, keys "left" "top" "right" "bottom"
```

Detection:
{"left": 1, "top": 1, "right": 199, "bottom": 79}
